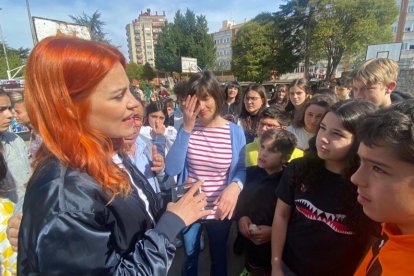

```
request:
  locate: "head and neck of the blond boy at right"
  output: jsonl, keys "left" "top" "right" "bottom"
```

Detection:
{"left": 351, "top": 58, "right": 412, "bottom": 107}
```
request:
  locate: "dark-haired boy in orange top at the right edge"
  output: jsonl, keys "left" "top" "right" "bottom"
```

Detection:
{"left": 351, "top": 100, "right": 414, "bottom": 276}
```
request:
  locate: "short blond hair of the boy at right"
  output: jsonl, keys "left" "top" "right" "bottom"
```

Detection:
{"left": 351, "top": 58, "right": 399, "bottom": 86}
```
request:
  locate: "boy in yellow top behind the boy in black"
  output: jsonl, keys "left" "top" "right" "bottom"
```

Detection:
{"left": 246, "top": 106, "right": 303, "bottom": 167}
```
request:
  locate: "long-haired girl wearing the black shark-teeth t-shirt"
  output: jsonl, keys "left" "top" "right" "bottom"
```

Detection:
{"left": 272, "top": 100, "right": 375, "bottom": 275}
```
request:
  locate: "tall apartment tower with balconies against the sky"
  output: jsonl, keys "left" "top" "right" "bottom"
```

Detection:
{"left": 126, "top": 9, "right": 166, "bottom": 67}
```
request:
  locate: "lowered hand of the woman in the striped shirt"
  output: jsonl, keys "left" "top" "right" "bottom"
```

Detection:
{"left": 214, "top": 182, "right": 241, "bottom": 220}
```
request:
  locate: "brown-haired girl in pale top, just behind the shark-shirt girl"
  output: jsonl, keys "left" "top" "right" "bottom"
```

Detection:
{"left": 288, "top": 95, "right": 334, "bottom": 150}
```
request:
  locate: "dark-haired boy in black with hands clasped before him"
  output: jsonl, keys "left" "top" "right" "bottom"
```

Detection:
{"left": 236, "top": 129, "right": 296, "bottom": 275}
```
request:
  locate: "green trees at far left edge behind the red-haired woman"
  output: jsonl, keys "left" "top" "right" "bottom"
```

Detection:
{"left": 0, "top": 43, "right": 29, "bottom": 79}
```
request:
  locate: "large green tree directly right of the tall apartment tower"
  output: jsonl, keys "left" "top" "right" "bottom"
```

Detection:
{"left": 155, "top": 9, "right": 215, "bottom": 72}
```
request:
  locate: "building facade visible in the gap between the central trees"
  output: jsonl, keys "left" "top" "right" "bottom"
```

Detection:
{"left": 211, "top": 20, "right": 243, "bottom": 70}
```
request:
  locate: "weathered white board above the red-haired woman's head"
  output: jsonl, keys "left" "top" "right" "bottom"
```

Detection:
{"left": 33, "top": 17, "right": 91, "bottom": 42}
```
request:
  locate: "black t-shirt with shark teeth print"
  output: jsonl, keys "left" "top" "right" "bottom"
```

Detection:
{"left": 278, "top": 158, "right": 370, "bottom": 276}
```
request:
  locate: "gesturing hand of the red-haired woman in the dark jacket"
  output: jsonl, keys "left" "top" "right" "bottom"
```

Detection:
{"left": 167, "top": 179, "right": 212, "bottom": 226}
